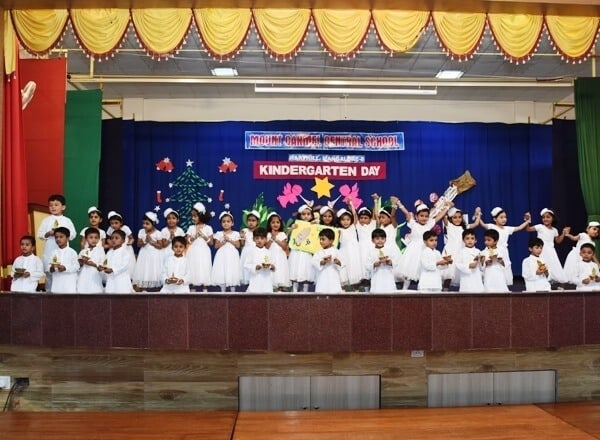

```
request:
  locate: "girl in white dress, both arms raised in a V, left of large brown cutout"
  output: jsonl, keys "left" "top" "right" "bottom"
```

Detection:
{"left": 393, "top": 197, "right": 450, "bottom": 290}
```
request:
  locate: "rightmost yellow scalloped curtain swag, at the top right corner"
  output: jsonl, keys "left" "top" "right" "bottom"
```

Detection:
{"left": 546, "top": 15, "right": 598, "bottom": 60}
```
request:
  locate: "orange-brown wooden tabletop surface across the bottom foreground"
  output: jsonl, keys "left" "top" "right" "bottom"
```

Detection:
{"left": 0, "top": 402, "right": 600, "bottom": 440}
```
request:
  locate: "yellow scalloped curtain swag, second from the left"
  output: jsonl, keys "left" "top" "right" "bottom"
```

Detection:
{"left": 71, "top": 9, "right": 129, "bottom": 55}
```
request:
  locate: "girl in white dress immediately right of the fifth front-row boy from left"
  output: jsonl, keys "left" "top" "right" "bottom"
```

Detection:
{"left": 186, "top": 202, "right": 213, "bottom": 292}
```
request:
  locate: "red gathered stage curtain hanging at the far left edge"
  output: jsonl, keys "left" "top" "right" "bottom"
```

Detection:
{"left": 0, "top": 62, "right": 29, "bottom": 290}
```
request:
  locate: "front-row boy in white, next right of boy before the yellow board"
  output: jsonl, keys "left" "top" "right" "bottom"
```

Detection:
{"left": 366, "top": 228, "right": 400, "bottom": 293}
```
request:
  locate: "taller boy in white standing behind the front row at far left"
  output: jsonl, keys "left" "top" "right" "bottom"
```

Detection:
{"left": 37, "top": 194, "right": 77, "bottom": 291}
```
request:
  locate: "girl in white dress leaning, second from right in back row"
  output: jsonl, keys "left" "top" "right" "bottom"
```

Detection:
{"left": 527, "top": 208, "right": 568, "bottom": 284}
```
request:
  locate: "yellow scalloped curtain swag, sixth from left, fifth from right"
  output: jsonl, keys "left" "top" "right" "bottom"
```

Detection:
{"left": 313, "top": 9, "right": 371, "bottom": 56}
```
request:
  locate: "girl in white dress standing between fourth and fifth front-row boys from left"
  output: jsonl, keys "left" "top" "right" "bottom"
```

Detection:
{"left": 132, "top": 211, "right": 163, "bottom": 291}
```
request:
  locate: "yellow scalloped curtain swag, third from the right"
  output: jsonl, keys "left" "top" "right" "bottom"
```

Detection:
{"left": 431, "top": 11, "right": 485, "bottom": 58}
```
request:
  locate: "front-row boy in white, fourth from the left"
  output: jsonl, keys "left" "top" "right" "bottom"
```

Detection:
{"left": 98, "top": 229, "right": 133, "bottom": 293}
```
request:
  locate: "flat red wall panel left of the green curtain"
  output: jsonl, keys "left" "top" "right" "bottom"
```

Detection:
{"left": 19, "top": 58, "right": 66, "bottom": 206}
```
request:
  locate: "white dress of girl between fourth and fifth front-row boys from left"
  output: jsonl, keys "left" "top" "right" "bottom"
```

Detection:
{"left": 132, "top": 229, "right": 163, "bottom": 289}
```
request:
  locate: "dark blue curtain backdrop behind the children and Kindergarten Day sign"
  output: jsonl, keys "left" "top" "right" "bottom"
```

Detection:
{"left": 100, "top": 120, "right": 552, "bottom": 274}
